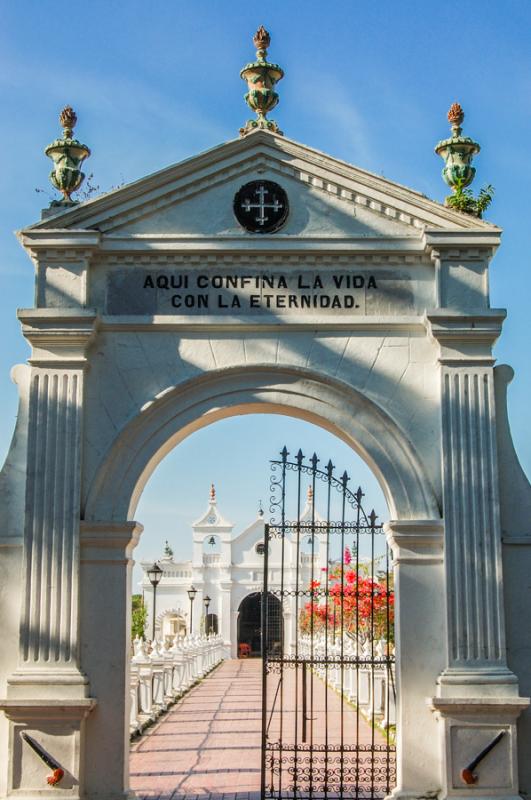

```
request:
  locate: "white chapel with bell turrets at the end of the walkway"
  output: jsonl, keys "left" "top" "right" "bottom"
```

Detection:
{"left": 140, "top": 485, "right": 326, "bottom": 658}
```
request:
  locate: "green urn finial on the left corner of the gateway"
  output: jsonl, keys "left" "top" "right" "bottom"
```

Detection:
{"left": 44, "top": 106, "right": 90, "bottom": 206}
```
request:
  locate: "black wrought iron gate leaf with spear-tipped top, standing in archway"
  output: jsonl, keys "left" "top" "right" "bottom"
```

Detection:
{"left": 261, "top": 448, "right": 396, "bottom": 800}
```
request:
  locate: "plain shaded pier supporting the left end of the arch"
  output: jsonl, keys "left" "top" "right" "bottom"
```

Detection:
{"left": 80, "top": 522, "right": 142, "bottom": 800}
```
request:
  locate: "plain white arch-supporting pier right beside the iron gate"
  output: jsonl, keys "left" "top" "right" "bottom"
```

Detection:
{"left": 384, "top": 520, "right": 446, "bottom": 798}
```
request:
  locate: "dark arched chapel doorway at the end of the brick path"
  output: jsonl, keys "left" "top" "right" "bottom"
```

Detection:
{"left": 238, "top": 592, "right": 284, "bottom": 658}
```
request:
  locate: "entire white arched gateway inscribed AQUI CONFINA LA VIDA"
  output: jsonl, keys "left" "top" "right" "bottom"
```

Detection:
{"left": 0, "top": 29, "right": 531, "bottom": 798}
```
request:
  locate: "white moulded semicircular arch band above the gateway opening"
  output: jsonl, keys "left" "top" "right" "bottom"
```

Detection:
{"left": 84, "top": 367, "right": 441, "bottom": 521}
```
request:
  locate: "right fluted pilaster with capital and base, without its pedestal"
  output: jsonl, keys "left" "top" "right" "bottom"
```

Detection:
{"left": 428, "top": 310, "right": 517, "bottom": 695}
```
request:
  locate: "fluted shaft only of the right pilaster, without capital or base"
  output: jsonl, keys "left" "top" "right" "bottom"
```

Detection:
{"left": 442, "top": 367, "right": 505, "bottom": 664}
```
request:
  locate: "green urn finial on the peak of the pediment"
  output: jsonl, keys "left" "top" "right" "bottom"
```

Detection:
{"left": 240, "top": 25, "right": 284, "bottom": 136}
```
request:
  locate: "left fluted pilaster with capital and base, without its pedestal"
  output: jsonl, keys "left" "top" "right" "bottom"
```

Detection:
{"left": 10, "top": 311, "right": 95, "bottom": 685}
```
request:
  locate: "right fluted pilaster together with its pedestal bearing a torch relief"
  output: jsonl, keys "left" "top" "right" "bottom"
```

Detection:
{"left": 427, "top": 309, "right": 529, "bottom": 798}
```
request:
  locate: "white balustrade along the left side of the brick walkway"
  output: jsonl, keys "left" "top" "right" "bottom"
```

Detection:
{"left": 129, "top": 634, "right": 225, "bottom": 736}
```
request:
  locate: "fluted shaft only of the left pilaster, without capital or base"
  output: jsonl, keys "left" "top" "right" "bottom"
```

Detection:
{"left": 21, "top": 368, "right": 83, "bottom": 663}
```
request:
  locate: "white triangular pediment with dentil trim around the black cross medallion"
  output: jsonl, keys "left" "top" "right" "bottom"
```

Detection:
{"left": 27, "top": 131, "right": 498, "bottom": 239}
